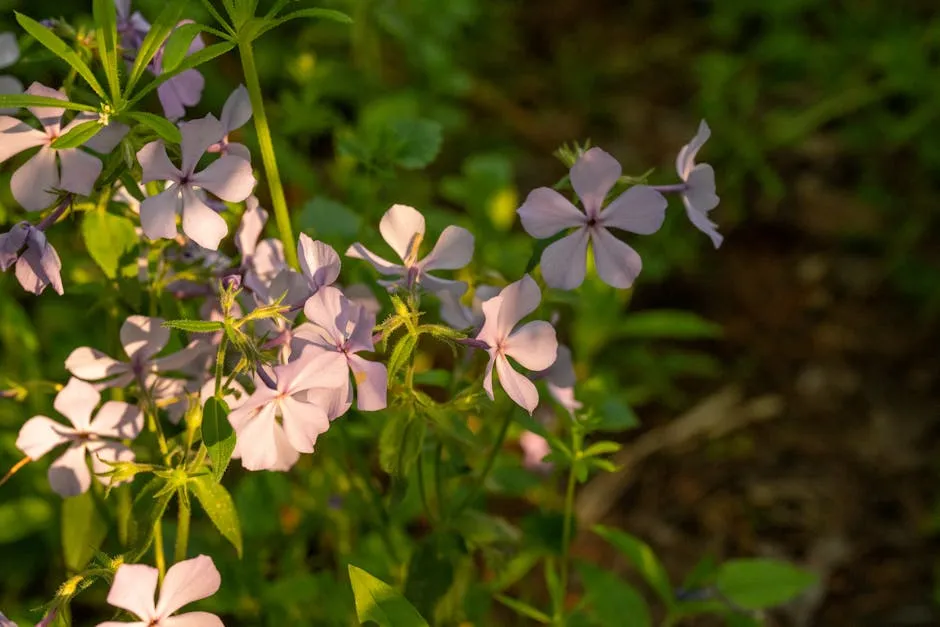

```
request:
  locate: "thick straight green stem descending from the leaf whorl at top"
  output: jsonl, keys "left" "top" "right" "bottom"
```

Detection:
{"left": 238, "top": 36, "right": 300, "bottom": 270}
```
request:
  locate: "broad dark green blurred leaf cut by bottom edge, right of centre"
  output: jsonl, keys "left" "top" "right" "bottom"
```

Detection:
{"left": 577, "top": 562, "right": 653, "bottom": 627}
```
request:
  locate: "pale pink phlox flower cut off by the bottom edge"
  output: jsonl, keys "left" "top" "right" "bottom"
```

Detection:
{"left": 98, "top": 555, "right": 224, "bottom": 627}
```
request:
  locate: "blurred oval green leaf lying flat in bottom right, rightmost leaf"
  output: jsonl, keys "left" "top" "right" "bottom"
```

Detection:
{"left": 715, "top": 558, "right": 817, "bottom": 610}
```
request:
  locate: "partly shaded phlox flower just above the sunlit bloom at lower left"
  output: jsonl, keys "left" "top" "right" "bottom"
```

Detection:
{"left": 65, "top": 316, "right": 206, "bottom": 397}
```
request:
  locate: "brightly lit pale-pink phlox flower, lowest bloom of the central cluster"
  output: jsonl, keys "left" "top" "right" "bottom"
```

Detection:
{"left": 229, "top": 347, "right": 348, "bottom": 470}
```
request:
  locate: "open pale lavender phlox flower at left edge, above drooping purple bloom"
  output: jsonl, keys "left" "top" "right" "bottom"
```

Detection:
{"left": 0, "top": 83, "right": 102, "bottom": 211}
